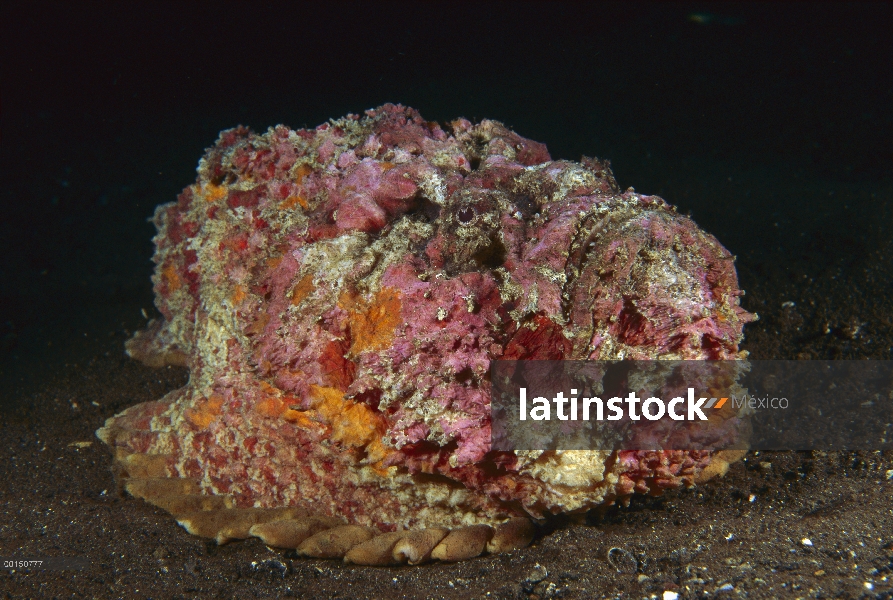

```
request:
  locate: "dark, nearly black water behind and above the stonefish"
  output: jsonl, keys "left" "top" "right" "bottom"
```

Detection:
{"left": 0, "top": 0, "right": 893, "bottom": 401}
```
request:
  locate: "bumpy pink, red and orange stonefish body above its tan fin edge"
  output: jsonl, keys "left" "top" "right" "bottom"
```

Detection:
{"left": 98, "top": 105, "right": 752, "bottom": 531}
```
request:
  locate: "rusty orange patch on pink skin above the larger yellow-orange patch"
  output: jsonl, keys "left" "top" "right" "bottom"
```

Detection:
{"left": 338, "top": 288, "right": 401, "bottom": 356}
